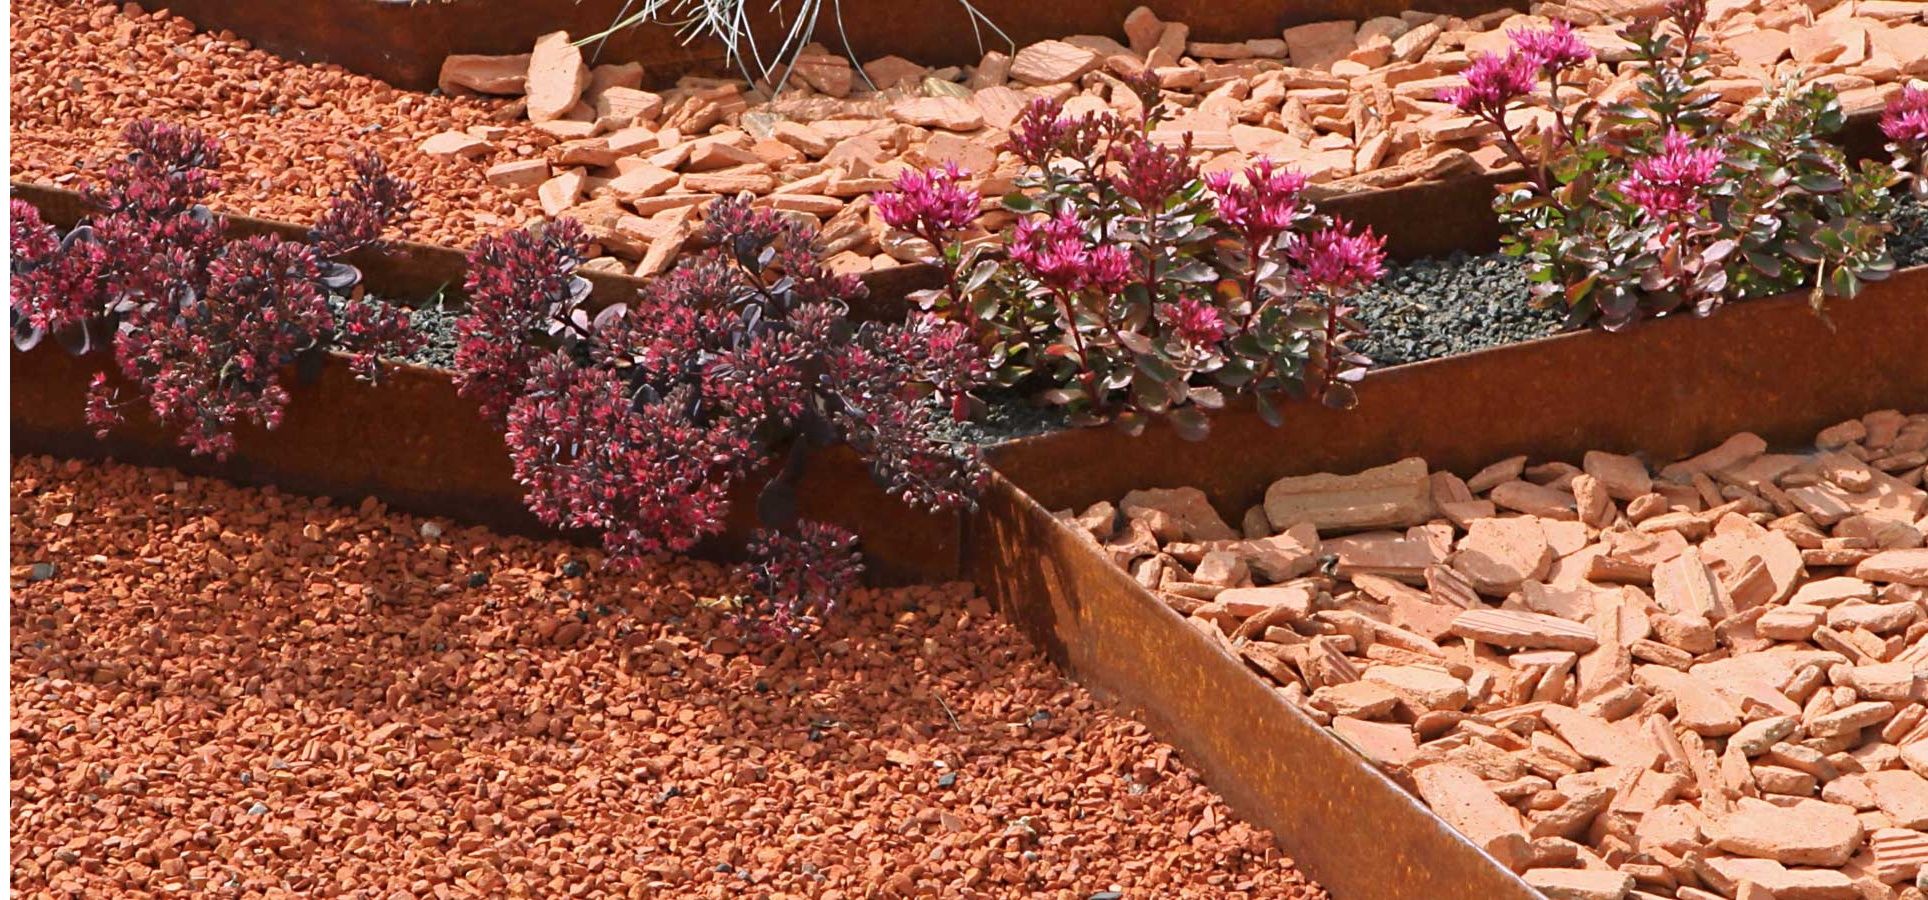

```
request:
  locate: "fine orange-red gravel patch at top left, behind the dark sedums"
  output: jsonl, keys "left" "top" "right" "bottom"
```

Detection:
{"left": 8, "top": 0, "right": 549, "bottom": 247}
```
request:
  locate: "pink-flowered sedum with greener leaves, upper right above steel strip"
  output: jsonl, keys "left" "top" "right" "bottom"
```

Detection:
{"left": 1442, "top": 0, "right": 1893, "bottom": 330}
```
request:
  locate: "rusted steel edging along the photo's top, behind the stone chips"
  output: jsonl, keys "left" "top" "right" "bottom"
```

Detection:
{"left": 150, "top": 0, "right": 1506, "bottom": 91}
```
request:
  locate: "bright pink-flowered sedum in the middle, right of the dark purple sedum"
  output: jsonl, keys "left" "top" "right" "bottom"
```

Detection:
{"left": 875, "top": 87, "right": 1384, "bottom": 439}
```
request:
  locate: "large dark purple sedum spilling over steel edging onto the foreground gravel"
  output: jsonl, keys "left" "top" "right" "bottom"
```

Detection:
{"left": 457, "top": 197, "right": 987, "bottom": 634}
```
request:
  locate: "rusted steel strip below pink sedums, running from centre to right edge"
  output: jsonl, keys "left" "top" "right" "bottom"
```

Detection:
{"left": 991, "top": 266, "right": 1928, "bottom": 522}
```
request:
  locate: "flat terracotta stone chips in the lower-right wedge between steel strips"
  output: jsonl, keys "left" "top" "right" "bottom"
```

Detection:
{"left": 1060, "top": 409, "right": 1928, "bottom": 900}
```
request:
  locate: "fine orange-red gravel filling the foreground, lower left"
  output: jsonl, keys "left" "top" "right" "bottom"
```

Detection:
{"left": 12, "top": 457, "right": 1323, "bottom": 898}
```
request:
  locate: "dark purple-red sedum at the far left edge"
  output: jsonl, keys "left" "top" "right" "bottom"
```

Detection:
{"left": 10, "top": 119, "right": 420, "bottom": 457}
